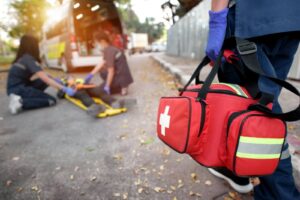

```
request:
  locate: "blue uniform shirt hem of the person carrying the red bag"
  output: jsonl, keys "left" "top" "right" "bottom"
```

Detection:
{"left": 235, "top": 0, "right": 300, "bottom": 38}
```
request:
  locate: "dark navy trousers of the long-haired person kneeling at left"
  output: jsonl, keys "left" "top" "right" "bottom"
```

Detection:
{"left": 8, "top": 79, "right": 56, "bottom": 110}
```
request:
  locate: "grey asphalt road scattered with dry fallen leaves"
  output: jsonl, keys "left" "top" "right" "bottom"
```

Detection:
{"left": 0, "top": 55, "right": 251, "bottom": 200}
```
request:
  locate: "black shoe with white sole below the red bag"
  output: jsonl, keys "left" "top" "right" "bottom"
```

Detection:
{"left": 208, "top": 168, "right": 253, "bottom": 193}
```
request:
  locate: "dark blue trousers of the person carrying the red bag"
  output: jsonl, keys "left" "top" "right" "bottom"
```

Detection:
{"left": 254, "top": 34, "right": 300, "bottom": 200}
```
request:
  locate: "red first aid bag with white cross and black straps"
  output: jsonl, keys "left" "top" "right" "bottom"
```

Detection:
{"left": 157, "top": 47, "right": 300, "bottom": 176}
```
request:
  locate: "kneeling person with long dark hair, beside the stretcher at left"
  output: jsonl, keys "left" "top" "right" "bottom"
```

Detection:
{"left": 7, "top": 35, "right": 76, "bottom": 114}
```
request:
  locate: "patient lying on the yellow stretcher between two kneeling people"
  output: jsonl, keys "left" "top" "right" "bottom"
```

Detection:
{"left": 56, "top": 76, "right": 136, "bottom": 117}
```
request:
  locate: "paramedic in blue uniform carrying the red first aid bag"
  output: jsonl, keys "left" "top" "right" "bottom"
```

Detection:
{"left": 206, "top": 0, "right": 300, "bottom": 200}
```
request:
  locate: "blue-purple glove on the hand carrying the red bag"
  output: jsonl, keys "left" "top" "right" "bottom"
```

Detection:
{"left": 205, "top": 8, "right": 228, "bottom": 61}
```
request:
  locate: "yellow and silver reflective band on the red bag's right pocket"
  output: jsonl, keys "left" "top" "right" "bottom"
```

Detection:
{"left": 236, "top": 136, "right": 284, "bottom": 159}
